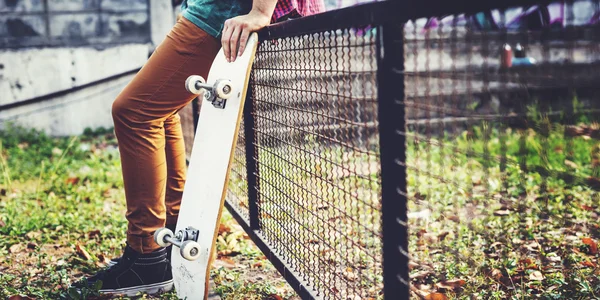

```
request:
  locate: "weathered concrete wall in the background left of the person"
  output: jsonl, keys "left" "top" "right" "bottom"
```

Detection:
{"left": 0, "top": 0, "right": 174, "bottom": 135}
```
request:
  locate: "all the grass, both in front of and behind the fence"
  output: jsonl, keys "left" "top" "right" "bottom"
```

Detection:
{"left": 0, "top": 106, "right": 600, "bottom": 299}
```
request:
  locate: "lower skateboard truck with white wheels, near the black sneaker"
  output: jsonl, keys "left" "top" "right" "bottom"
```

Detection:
{"left": 154, "top": 227, "right": 200, "bottom": 260}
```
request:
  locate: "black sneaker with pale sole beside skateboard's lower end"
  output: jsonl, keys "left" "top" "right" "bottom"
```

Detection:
{"left": 73, "top": 245, "right": 173, "bottom": 297}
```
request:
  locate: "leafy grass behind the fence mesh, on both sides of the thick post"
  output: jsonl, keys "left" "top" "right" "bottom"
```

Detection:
{"left": 226, "top": 109, "right": 600, "bottom": 299}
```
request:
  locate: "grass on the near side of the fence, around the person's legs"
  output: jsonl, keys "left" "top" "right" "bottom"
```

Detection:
{"left": 0, "top": 123, "right": 294, "bottom": 299}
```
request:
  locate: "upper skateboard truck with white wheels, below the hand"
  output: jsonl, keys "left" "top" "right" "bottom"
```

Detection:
{"left": 185, "top": 75, "right": 233, "bottom": 109}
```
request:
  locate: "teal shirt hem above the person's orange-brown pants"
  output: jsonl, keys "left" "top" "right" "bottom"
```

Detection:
{"left": 181, "top": 0, "right": 252, "bottom": 39}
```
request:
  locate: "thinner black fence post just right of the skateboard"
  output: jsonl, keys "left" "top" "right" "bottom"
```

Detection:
{"left": 244, "top": 72, "right": 260, "bottom": 230}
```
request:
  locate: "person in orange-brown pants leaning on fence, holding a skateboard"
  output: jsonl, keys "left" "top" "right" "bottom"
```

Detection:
{"left": 74, "top": 0, "right": 324, "bottom": 296}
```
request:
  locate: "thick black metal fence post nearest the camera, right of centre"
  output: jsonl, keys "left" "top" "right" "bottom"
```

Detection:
{"left": 377, "top": 22, "right": 410, "bottom": 300}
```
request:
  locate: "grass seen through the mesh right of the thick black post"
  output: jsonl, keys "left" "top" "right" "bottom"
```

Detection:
{"left": 408, "top": 112, "right": 600, "bottom": 299}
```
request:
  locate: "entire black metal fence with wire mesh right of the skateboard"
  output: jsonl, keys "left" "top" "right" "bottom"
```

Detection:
{"left": 216, "top": 0, "right": 600, "bottom": 299}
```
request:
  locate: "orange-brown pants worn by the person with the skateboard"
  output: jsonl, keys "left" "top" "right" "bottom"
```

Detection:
{"left": 112, "top": 18, "right": 221, "bottom": 253}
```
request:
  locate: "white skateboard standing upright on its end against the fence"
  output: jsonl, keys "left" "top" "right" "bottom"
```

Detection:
{"left": 154, "top": 33, "right": 258, "bottom": 300}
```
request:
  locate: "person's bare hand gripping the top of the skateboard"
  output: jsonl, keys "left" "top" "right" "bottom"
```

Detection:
{"left": 221, "top": 10, "right": 271, "bottom": 62}
